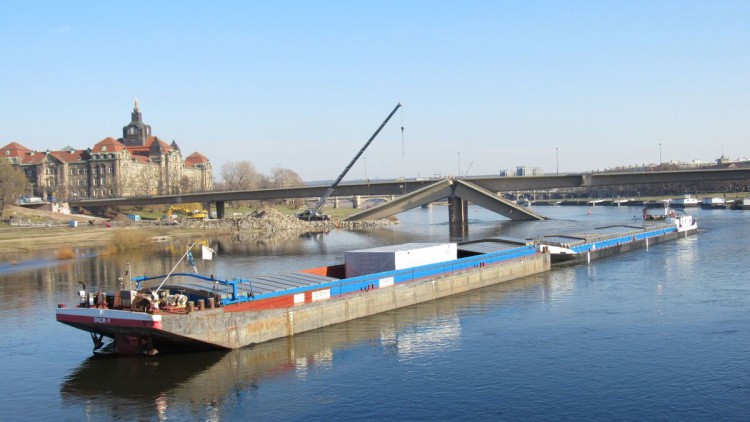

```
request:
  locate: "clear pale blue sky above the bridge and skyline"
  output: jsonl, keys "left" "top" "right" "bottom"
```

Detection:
{"left": 0, "top": 0, "right": 750, "bottom": 180}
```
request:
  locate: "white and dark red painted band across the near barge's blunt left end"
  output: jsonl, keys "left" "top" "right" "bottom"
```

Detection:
{"left": 57, "top": 308, "right": 161, "bottom": 329}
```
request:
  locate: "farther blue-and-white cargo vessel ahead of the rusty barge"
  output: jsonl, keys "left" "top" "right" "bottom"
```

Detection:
{"left": 537, "top": 212, "right": 698, "bottom": 266}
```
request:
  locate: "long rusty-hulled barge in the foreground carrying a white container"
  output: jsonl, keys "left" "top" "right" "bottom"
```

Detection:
{"left": 56, "top": 238, "right": 551, "bottom": 355}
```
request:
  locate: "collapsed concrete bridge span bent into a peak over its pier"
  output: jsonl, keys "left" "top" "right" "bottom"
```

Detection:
{"left": 344, "top": 179, "right": 546, "bottom": 224}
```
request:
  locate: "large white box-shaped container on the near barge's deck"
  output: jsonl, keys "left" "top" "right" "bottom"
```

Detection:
{"left": 344, "top": 243, "right": 457, "bottom": 278}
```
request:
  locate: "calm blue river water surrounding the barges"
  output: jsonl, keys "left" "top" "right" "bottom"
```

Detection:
{"left": 0, "top": 207, "right": 750, "bottom": 421}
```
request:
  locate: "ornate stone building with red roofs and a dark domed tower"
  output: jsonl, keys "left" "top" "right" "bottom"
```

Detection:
{"left": 0, "top": 100, "right": 213, "bottom": 201}
